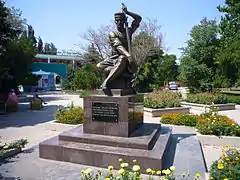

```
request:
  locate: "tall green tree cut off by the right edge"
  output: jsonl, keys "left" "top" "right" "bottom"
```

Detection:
{"left": 216, "top": 0, "right": 240, "bottom": 85}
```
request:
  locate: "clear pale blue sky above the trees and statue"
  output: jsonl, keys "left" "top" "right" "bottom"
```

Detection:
{"left": 6, "top": 0, "right": 224, "bottom": 57}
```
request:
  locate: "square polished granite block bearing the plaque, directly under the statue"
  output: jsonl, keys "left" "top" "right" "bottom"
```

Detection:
{"left": 83, "top": 94, "right": 144, "bottom": 137}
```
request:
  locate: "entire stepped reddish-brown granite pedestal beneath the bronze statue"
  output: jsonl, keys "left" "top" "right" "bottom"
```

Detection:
{"left": 39, "top": 89, "right": 171, "bottom": 173}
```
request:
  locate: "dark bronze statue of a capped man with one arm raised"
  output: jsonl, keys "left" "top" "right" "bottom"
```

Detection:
{"left": 97, "top": 6, "right": 142, "bottom": 90}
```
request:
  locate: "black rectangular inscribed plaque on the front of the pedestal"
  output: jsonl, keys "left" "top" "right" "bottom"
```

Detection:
{"left": 92, "top": 102, "right": 118, "bottom": 122}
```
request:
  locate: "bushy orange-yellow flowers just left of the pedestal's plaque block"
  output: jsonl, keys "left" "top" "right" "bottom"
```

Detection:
{"left": 55, "top": 105, "right": 84, "bottom": 124}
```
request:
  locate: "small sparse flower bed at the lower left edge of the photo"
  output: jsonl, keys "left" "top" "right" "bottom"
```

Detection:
{"left": 0, "top": 139, "right": 28, "bottom": 159}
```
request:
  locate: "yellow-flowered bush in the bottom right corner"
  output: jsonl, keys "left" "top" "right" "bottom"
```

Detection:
{"left": 210, "top": 146, "right": 240, "bottom": 180}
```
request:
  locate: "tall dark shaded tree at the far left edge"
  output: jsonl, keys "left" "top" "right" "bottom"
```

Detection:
{"left": 0, "top": 1, "right": 36, "bottom": 84}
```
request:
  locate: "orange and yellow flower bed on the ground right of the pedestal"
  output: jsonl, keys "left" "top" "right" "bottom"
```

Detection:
{"left": 160, "top": 110, "right": 240, "bottom": 136}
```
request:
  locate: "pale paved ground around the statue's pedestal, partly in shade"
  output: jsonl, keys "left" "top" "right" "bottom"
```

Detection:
{"left": 0, "top": 94, "right": 240, "bottom": 180}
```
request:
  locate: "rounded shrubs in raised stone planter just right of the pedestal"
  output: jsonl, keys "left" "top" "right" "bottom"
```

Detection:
{"left": 144, "top": 90, "right": 181, "bottom": 108}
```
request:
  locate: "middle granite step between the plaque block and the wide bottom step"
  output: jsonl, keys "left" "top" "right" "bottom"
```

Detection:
{"left": 59, "top": 124, "right": 161, "bottom": 150}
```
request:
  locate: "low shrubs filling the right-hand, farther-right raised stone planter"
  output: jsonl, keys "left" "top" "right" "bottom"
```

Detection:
{"left": 186, "top": 92, "right": 228, "bottom": 105}
